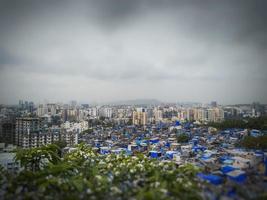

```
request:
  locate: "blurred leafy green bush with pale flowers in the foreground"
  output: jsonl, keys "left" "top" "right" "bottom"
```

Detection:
{"left": 0, "top": 144, "right": 200, "bottom": 199}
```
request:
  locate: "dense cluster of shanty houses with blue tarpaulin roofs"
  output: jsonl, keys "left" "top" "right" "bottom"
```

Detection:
{"left": 79, "top": 122, "right": 267, "bottom": 198}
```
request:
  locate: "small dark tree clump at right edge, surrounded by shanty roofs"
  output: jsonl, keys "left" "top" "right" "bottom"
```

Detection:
{"left": 238, "top": 135, "right": 267, "bottom": 150}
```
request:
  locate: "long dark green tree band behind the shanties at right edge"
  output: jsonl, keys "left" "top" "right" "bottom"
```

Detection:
{"left": 208, "top": 117, "right": 267, "bottom": 130}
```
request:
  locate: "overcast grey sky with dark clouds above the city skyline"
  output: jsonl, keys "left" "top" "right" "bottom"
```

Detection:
{"left": 0, "top": 0, "right": 267, "bottom": 104}
